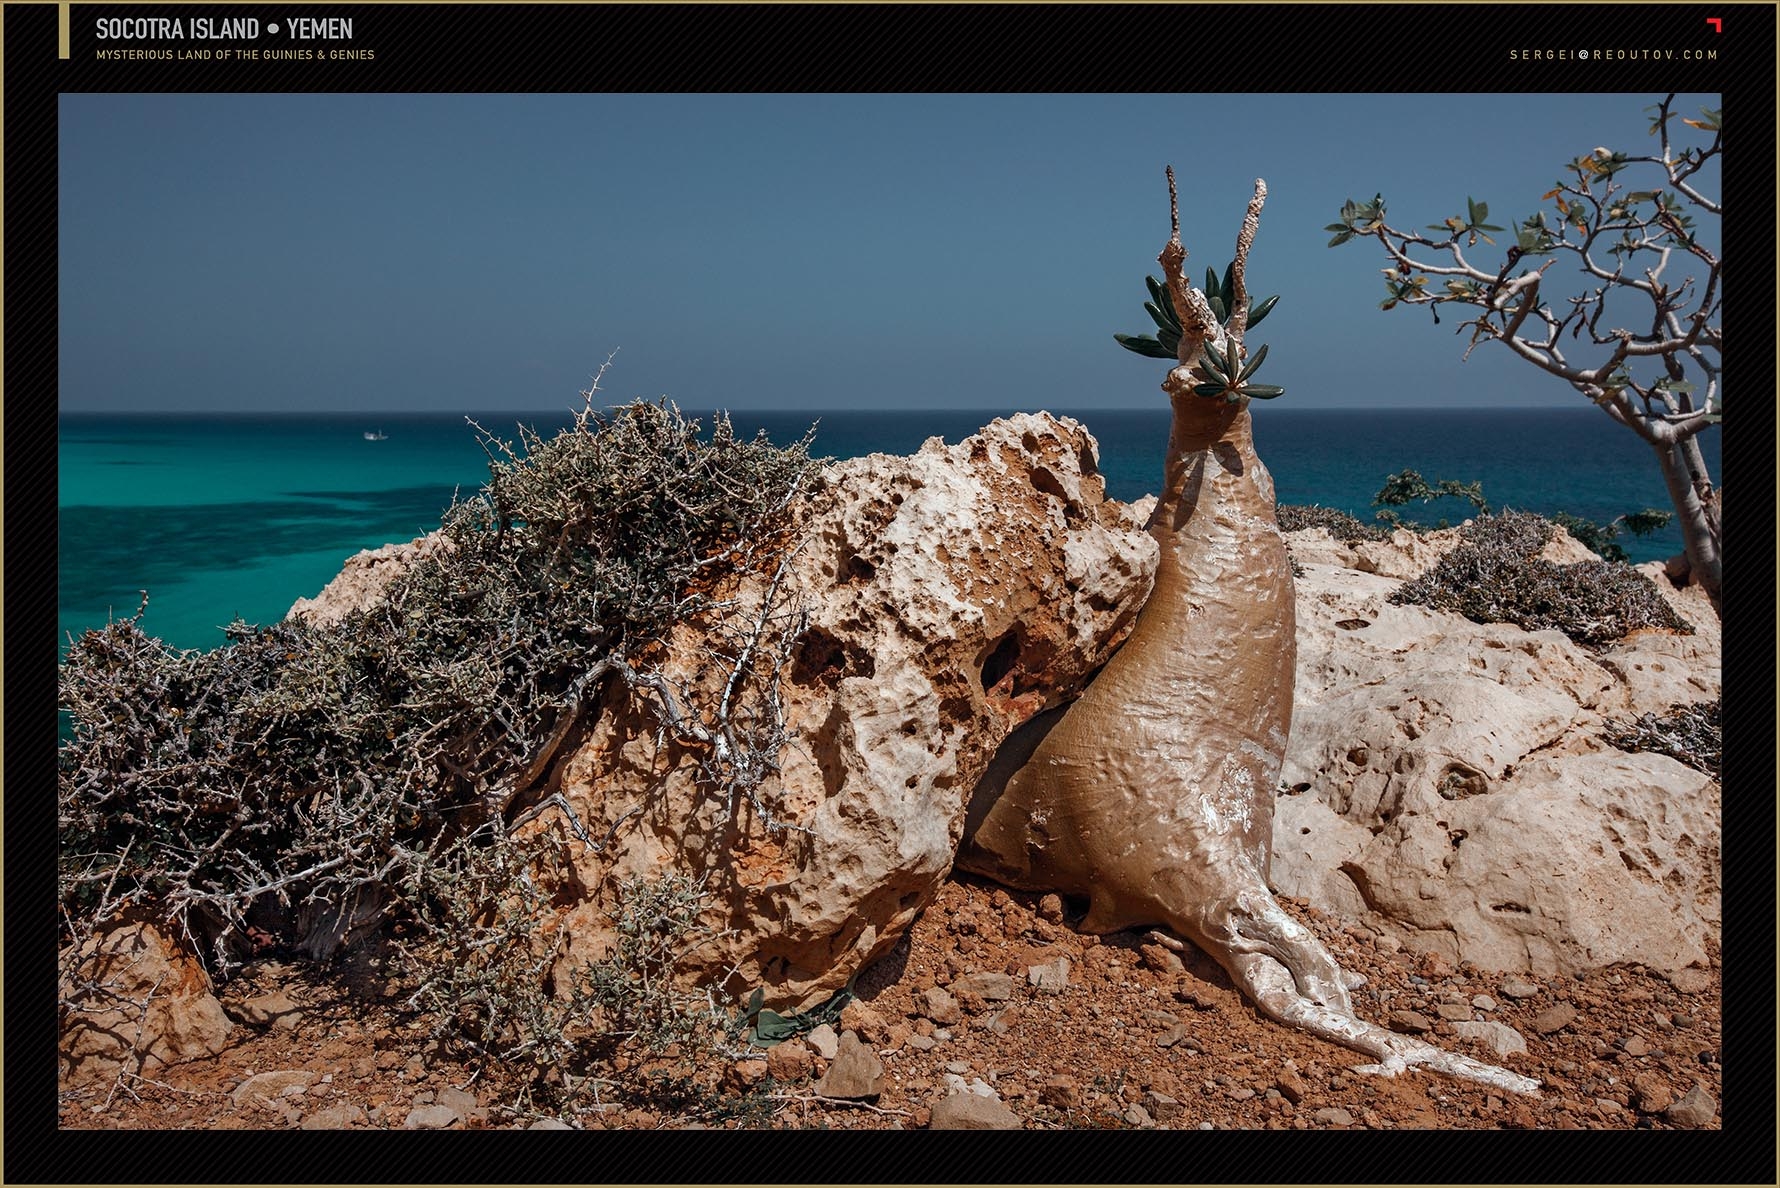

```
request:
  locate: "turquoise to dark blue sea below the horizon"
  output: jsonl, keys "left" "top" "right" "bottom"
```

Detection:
{"left": 57, "top": 408, "right": 1723, "bottom": 648}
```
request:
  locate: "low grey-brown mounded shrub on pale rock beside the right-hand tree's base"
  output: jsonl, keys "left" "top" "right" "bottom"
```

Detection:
{"left": 1390, "top": 511, "right": 1693, "bottom": 647}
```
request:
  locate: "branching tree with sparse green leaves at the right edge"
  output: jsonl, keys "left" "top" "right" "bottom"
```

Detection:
{"left": 1326, "top": 94, "right": 1725, "bottom": 606}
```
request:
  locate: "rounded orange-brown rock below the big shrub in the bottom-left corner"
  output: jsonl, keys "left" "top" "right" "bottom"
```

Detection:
{"left": 59, "top": 921, "right": 230, "bottom": 1085}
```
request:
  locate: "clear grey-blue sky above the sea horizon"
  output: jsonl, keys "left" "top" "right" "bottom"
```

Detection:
{"left": 59, "top": 93, "right": 1718, "bottom": 411}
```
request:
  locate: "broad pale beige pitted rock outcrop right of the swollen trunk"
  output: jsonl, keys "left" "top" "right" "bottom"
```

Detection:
{"left": 1273, "top": 529, "right": 1719, "bottom": 976}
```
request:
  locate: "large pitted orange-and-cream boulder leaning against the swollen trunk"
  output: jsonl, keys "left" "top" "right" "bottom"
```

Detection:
{"left": 539, "top": 413, "right": 1157, "bottom": 1006}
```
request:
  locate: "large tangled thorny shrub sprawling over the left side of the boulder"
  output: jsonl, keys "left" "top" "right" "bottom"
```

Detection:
{"left": 57, "top": 395, "right": 815, "bottom": 1104}
